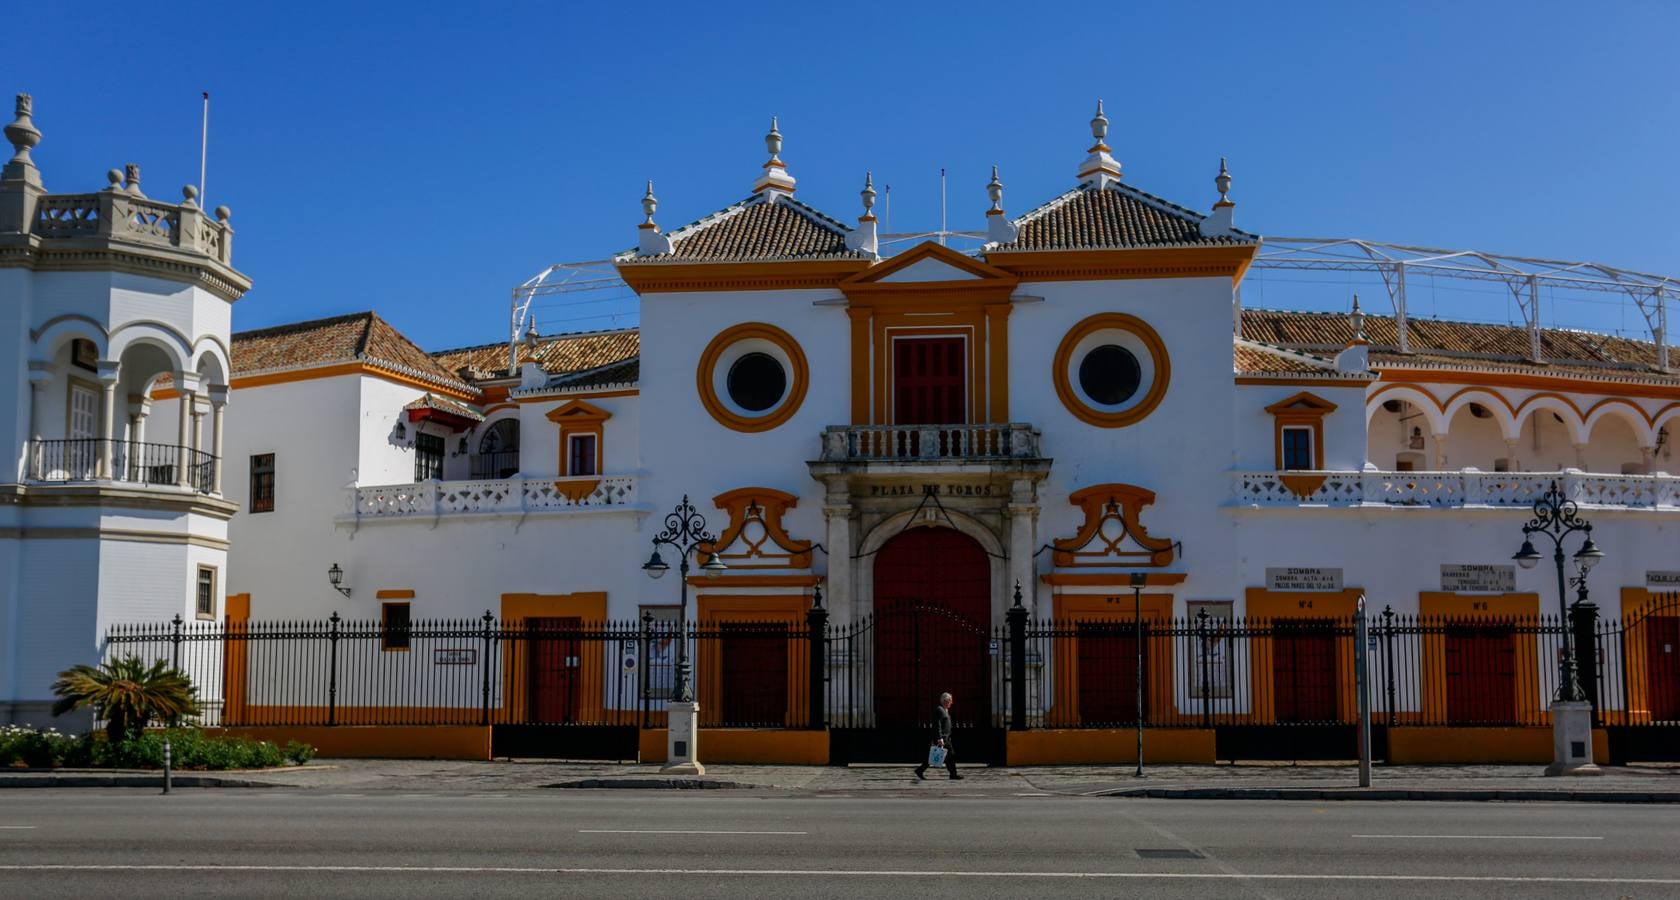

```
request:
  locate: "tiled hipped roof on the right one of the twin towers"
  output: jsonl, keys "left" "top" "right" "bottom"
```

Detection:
{"left": 988, "top": 185, "right": 1258, "bottom": 252}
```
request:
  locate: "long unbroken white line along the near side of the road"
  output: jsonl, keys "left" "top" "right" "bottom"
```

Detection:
{"left": 0, "top": 863, "right": 1680, "bottom": 885}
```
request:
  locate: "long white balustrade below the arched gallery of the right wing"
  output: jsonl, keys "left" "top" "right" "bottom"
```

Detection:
{"left": 1233, "top": 470, "right": 1680, "bottom": 509}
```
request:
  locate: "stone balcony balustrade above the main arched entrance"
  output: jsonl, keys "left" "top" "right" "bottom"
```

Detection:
{"left": 823, "top": 421, "right": 1038, "bottom": 462}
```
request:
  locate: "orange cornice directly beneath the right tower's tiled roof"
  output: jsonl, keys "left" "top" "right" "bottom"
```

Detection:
{"left": 986, "top": 245, "right": 1260, "bottom": 285}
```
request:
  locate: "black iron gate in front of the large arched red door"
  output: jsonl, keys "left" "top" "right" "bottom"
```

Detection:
{"left": 828, "top": 603, "right": 1005, "bottom": 766}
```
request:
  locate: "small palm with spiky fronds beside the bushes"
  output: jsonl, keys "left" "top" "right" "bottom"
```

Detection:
{"left": 52, "top": 657, "right": 198, "bottom": 740}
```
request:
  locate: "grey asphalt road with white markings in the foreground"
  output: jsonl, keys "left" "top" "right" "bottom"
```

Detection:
{"left": 0, "top": 789, "right": 1680, "bottom": 900}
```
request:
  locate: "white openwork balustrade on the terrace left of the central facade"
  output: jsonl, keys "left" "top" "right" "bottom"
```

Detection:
{"left": 349, "top": 475, "right": 635, "bottom": 521}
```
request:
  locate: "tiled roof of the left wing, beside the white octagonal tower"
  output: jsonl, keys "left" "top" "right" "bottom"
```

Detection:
{"left": 232, "top": 312, "right": 470, "bottom": 390}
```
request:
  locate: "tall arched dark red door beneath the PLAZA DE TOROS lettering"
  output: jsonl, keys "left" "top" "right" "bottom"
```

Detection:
{"left": 874, "top": 527, "right": 991, "bottom": 727}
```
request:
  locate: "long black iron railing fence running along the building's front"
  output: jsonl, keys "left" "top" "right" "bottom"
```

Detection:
{"left": 106, "top": 596, "right": 1680, "bottom": 730}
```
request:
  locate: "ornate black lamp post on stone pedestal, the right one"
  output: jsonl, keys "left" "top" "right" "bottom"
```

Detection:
{"left": 1512, "top": 480, "right": 1604, "bottom": 776}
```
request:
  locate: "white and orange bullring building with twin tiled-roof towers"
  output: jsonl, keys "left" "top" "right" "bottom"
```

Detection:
{"left": 0, "top": 94, "right": 1680, "bottom": 762}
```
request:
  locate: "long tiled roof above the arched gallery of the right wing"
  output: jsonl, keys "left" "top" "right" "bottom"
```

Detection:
{"left": 1242, "top": 309, "right": 1680, "bottom": 381}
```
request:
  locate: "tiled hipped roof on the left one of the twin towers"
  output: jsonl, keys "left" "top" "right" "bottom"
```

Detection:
{"left": 617, "top": 195, "right": 872, "bottom": 264}
